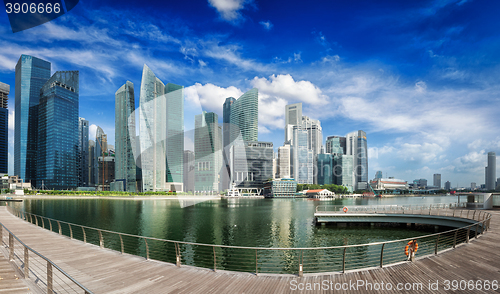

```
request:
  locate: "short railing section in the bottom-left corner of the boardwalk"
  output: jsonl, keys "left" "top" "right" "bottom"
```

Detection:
{"left": 0, "top": 215, "right": 92, "bottom": 294}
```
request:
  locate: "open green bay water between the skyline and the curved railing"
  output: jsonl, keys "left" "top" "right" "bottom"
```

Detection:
{"left": 17, "top": 196, "right": 457, "bottom": 248}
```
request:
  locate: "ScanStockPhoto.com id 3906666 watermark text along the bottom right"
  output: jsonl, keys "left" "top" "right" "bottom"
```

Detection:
{"left": 290, "top": 279, "right": 499, "bottom": 292}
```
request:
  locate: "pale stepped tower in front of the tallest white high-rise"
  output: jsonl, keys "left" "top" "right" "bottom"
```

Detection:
{"left": 292, "top": 126, "right": 314, "bottom": 184}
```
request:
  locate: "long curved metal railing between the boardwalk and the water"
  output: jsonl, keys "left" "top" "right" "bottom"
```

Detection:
{"left": 9, "top": 206, "right": 491, "bottom": 276}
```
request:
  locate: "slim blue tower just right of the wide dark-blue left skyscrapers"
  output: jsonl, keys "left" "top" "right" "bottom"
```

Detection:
{"left": 78, "top": 117, "right": 89, "bottom": 187}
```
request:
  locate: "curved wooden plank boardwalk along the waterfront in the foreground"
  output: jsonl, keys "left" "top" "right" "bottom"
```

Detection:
{"left": 0, "top": 207, "right": 500, "bottom": 294}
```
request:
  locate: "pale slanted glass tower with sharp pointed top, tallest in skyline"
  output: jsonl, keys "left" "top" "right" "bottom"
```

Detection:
{"left": 139, "top": 65, "right": 167, "bottom": 192}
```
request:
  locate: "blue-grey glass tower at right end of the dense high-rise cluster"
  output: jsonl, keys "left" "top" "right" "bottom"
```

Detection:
{"left": 346, "top": 130, "right": 368, "bottom": 190}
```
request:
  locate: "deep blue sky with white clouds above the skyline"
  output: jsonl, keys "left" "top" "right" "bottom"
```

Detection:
{"left": 0, "top": 0, "right": 500, "bottom": 186}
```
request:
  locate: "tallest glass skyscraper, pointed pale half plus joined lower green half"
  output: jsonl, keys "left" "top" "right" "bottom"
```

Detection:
{"left": 140, "top": 65, "right": 184, "bottom": 192}
